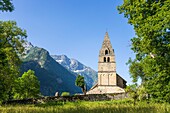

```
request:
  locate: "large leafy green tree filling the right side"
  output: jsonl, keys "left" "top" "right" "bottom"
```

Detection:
{"left": 118, "top": 0, "right": 170, "bottom": 102}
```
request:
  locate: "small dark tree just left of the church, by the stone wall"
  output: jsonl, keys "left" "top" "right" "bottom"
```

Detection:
{"left": 75, "top": 75, "right": 86, "bottom": 95}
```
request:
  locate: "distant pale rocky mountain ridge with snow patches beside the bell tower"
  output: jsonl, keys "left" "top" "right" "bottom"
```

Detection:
{"left": 51, "top": 55, "right": 97, "bottom": 89}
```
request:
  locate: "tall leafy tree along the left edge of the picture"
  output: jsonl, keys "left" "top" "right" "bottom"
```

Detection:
{"left": 0, "top": 21, "right": 26, "bottom": 101}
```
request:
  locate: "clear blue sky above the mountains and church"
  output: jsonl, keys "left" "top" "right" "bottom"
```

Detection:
{"left": 0, "top": 0, "right": 135, "bottom": 83}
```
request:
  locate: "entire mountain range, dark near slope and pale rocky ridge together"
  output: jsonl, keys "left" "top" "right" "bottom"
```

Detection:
{"left": 21, "top": 41, "right": 97, "bottom": 96}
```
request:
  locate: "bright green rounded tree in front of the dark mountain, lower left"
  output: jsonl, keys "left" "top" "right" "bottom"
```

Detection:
{"left": 14, "top": 70, "right": 40, "bottom": 99}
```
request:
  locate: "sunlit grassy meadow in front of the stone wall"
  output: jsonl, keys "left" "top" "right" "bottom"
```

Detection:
{"left": 0, "top": 100, "right": 170, "bottom": 113}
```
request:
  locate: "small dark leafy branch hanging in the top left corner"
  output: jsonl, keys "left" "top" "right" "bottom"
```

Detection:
{"left": 0, "top": 0, "right": 14, "bottom": 12}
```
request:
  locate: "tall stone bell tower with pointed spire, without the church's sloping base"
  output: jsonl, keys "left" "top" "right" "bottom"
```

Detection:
{"left": 98, "top": 32, "right": 117, "bottom": 86}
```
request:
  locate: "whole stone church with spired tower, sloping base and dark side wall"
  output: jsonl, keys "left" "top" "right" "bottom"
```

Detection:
{"left": 87, "top": 32, "right": 126, "bottom": 94}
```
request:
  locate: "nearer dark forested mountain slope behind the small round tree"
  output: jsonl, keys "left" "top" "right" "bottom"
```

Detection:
{"left": 21, "top": 46, "right": 81, "bottom": 96}
